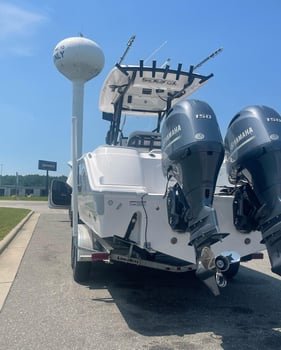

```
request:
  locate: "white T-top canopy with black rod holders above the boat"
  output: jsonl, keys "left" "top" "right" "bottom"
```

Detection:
{"left": 99, "top": 60, "right": 213, "bottom": 116}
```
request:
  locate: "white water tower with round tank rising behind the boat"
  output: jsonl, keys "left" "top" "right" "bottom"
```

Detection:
{"left": 53, "top": 36, "right": 104, "bottom": 158}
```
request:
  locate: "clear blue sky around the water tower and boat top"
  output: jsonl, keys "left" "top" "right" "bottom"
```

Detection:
{"left": 0, "top": 0, "right": 281, "bottom": 175}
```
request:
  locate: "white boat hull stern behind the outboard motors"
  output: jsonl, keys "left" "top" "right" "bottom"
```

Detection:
{"left": 78, "top": 146, "right": 265, "bottom": 263}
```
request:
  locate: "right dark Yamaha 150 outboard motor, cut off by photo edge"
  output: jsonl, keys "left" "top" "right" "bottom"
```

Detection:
{"left": 225, "top": 106, "right": 281, "bottom": 275}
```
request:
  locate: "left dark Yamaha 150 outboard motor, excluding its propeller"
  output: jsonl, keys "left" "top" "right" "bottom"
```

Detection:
{"left": 161, "top": 100, "right": 224, "bottom": 257}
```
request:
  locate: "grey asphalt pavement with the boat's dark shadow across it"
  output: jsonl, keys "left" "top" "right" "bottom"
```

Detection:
{"left": 0, "top": 203, "right": 281, "bottom": 350}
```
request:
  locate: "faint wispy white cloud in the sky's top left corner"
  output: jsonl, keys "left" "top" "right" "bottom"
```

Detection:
{"left": 0, "top": 2, "right": 47, "bottom": 56}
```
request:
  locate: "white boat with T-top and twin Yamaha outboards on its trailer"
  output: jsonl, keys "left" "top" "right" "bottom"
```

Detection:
{"left": 49, "top": 37, "right": 281, "bottom": 295}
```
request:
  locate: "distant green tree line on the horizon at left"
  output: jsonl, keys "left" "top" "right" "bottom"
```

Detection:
{"left": 0, "top": 175, "right": 67, "bottom": 187}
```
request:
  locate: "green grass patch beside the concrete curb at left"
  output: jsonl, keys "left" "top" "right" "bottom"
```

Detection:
{"left": 0, "top": 208, "right": 30, "bottom": 241}
